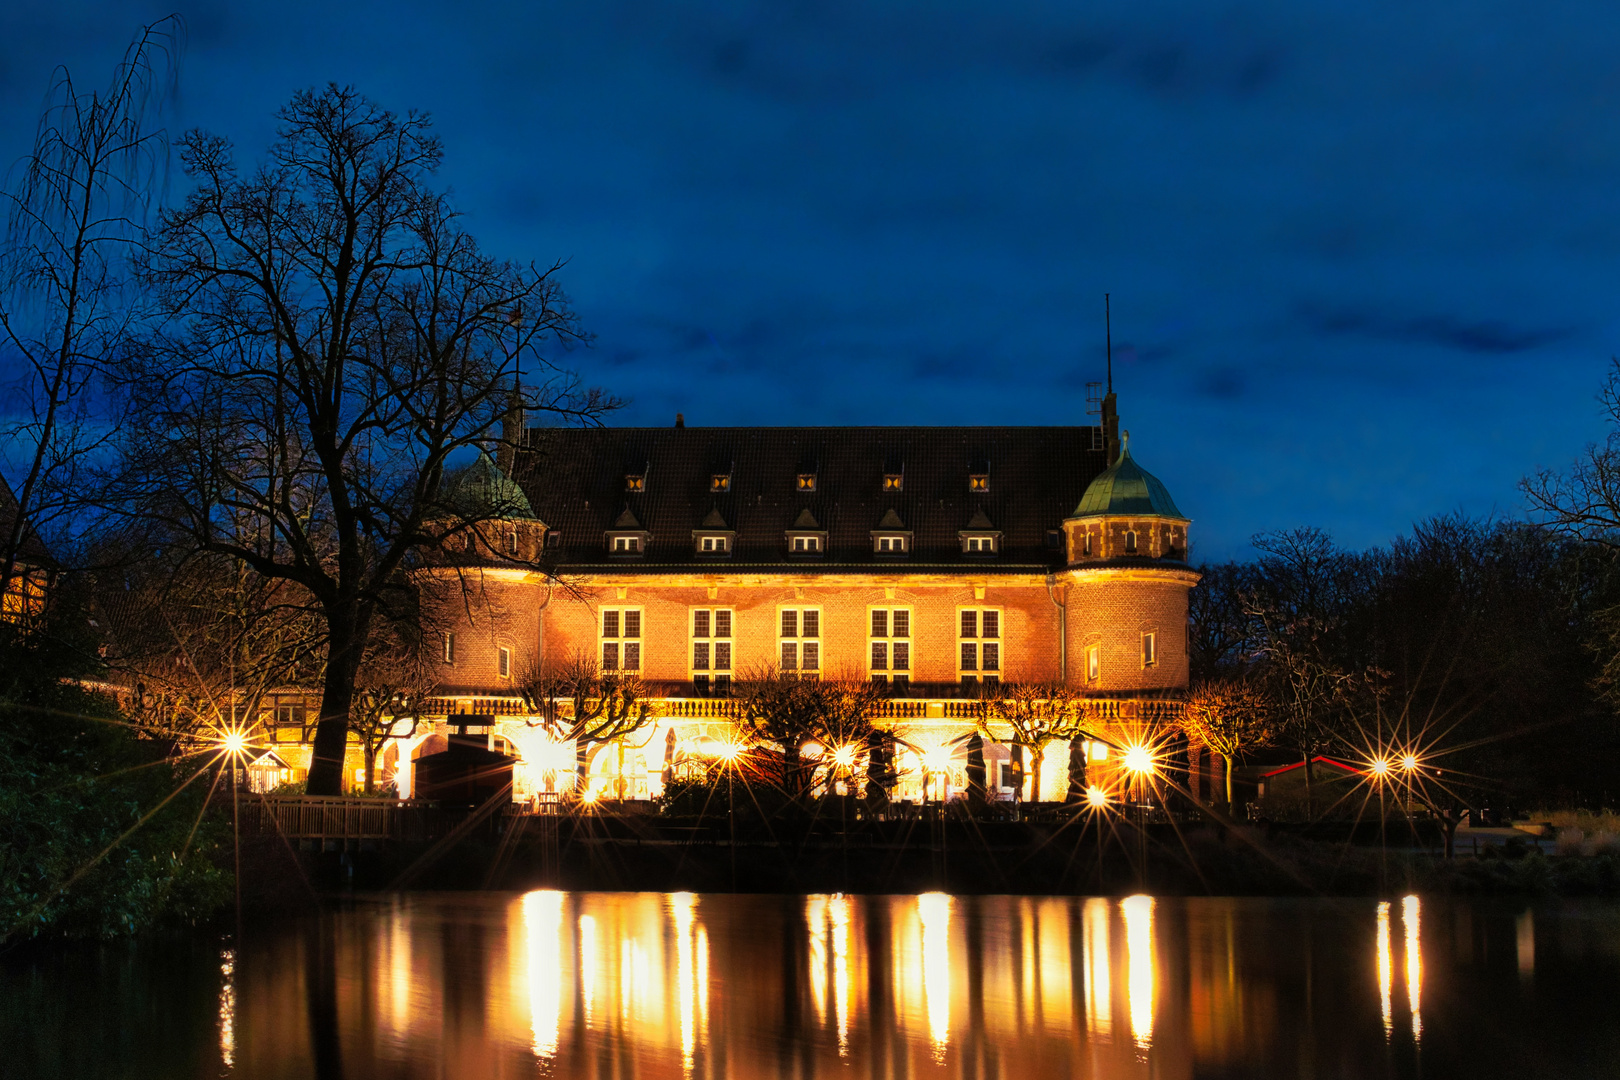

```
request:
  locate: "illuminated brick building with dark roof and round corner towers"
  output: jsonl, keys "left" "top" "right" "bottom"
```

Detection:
{"left": 370, "top": 395, "right": 1197, "bottom": 798}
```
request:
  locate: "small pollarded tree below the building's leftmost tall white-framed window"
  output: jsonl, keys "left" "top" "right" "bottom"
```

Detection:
{"left": 518, "top": 653, "right": 653, "bottom": 790}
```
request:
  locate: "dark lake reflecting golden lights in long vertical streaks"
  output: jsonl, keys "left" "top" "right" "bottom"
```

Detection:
{"left": 0, "top": 891, "right": 1620, "bottom": 1080}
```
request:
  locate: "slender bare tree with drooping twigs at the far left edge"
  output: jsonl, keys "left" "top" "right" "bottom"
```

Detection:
{"left": 0, "top": 16, "right": 181, "bottom": 608}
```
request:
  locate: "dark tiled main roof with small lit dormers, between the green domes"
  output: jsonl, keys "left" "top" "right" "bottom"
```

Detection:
{"left": 514, "top": 427, "right": 1108, "bottom": 570}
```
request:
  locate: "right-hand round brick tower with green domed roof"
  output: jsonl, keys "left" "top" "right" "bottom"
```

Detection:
{"left": 1059, "top": 432, "right": 1199, "bottom": 696}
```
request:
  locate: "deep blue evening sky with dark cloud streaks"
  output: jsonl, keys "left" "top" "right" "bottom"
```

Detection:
{"left": 0, "top": 0, "right": 1620, "bottom": 559}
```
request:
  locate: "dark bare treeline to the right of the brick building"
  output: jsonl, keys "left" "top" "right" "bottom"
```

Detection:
{"left": 1189, "top": 515, "right": 1620, "bottom": 814}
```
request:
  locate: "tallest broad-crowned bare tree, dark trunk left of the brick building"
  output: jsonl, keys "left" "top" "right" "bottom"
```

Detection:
{"left": 112, "top": 86, "right": 616, "bottom": 795}
